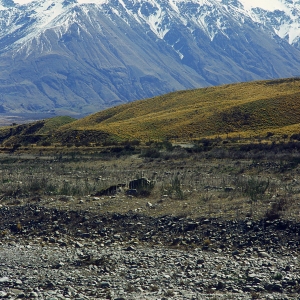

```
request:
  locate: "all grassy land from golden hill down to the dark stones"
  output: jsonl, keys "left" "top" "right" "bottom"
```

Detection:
{"left": 0, "top": 78, "right": 300, "bottom": 220}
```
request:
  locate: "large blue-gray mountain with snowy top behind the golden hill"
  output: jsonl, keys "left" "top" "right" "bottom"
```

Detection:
{"left": 0, "top": 0, "right": 300, "bottom": 113}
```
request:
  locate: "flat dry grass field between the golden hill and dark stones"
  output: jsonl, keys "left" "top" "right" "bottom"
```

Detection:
{"left": 0, "top": 142, "right": 300, "bottom": 221}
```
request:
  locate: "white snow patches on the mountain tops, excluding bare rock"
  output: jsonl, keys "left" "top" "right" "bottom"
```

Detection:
{"left": 7, "top": 0, "right": 300, "bottom": 48}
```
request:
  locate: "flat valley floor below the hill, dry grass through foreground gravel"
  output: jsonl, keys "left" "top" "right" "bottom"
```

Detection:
{"left": 0, "top": 150, "right": 300, "bottom": 300}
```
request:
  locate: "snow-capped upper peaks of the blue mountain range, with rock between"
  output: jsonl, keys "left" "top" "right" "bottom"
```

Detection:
{"left": 0, "top": 0, "right": 300, "bottom": 52}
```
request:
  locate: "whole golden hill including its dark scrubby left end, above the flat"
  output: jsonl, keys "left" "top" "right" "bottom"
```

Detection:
{"left": 0, "top": 78, "right": 300, "bottom": 146}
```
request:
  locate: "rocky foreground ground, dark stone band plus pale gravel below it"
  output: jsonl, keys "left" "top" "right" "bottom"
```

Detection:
{"left": 0, "top": 205, "right": 300, "bottom": 300}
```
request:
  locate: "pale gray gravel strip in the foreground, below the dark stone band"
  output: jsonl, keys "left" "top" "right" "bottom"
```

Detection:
{"left": 0, "top": 236, "right": 300, "bottom": 300}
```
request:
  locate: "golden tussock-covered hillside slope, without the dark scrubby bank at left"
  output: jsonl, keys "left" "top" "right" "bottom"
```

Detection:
{"left": 59, "top": 78, "right": 300, "bottom": 140}
